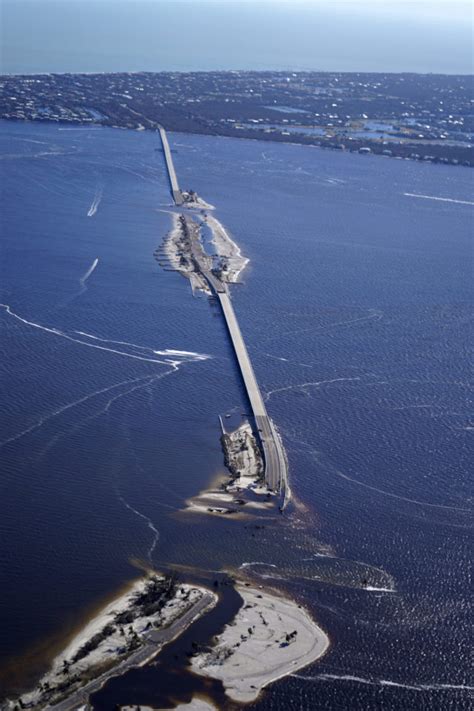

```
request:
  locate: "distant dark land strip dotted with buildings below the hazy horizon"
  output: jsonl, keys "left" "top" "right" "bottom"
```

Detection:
{"left": 0, "top": 71, "right": 474, "bottom": 167}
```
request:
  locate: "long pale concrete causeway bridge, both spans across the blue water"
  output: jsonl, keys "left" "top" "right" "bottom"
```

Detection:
{"left": 160, "top": 127, "right": 290, "bottom": 498}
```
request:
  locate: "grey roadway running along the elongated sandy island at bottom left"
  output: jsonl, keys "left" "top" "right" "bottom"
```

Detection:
{"left": 45, "top": 591, "right": 214, "bottom": 711}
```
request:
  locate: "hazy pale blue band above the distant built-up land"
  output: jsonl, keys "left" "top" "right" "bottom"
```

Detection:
{"left": 0, "top": 0, "right": 473, "bottom": 73}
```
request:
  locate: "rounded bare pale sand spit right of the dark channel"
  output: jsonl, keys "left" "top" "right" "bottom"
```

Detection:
{"left": 192, "top": 583, "right": 329, "bottom": 703}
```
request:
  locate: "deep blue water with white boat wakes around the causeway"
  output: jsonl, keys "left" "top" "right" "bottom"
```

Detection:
{"left": 0, "top": 122, "right": 473, "bottom": 711}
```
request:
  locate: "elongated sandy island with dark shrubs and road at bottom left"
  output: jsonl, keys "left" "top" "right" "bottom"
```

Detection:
{"left": 7, "top": 575, "right": 217, "bottom": 709}
